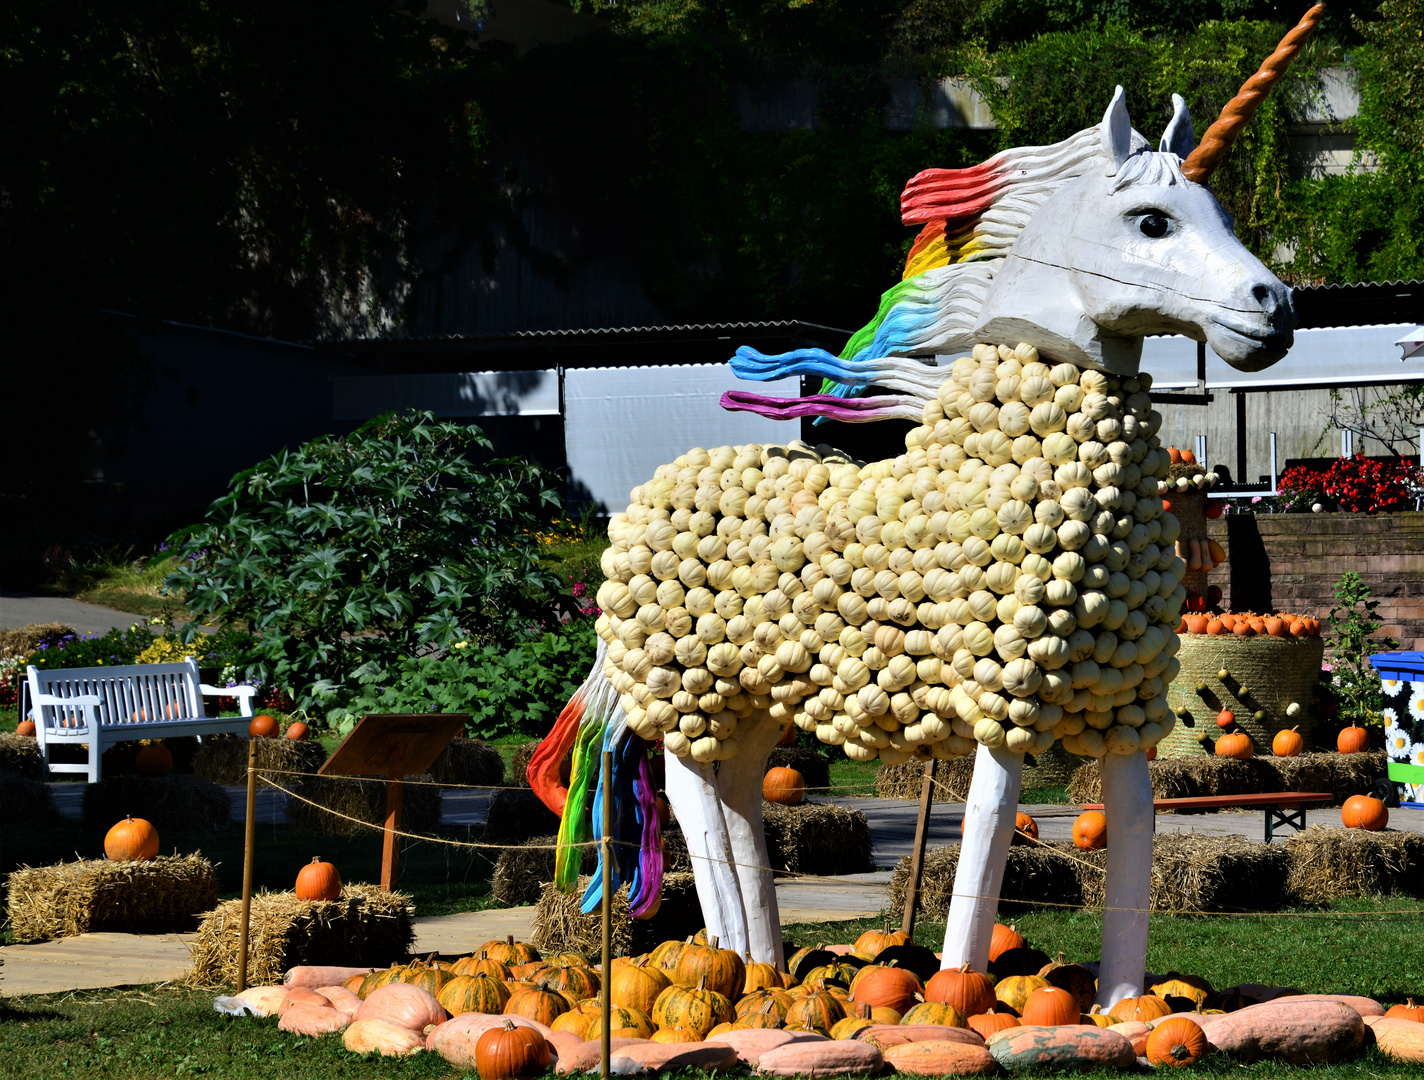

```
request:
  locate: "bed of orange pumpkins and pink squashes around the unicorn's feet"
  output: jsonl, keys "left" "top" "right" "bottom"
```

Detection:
{"left": 224, "top": 925, "right": 1424, "bottom": 1080}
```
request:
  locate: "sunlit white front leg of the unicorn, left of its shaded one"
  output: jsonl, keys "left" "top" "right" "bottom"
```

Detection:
{"left": 941, "top": 745, "right": 1024, "bottom": 972}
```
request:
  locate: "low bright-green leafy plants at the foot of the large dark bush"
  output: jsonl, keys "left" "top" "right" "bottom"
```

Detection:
{"left": 328, "top": 618, "right": 598, "bottom": 738}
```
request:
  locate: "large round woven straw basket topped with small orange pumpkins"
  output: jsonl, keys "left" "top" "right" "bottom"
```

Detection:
{"left": 1158, "top": 634, "right": 1326, "bottom": 758}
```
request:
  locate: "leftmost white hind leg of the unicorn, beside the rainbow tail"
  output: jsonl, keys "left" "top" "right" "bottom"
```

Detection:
{"left": 664, "top": 754, "right": 746, "bottom": 953}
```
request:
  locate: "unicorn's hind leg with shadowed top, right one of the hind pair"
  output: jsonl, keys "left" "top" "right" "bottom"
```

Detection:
{"left": 718, "top": 711, "right": 785, "bottom": 966}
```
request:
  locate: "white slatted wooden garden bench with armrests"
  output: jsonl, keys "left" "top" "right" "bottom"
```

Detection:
{"left": 27, "top": 657, "right": 258, "bottom": 784}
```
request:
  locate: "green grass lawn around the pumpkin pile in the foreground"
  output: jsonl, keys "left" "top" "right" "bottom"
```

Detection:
{"left": 0, "top": 896, "right": 1424, "bottom": 1080}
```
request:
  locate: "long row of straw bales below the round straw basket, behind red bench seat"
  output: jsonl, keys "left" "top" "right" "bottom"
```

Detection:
{"left": 1068, "top": 751, "right": 1386, "bottom": 814}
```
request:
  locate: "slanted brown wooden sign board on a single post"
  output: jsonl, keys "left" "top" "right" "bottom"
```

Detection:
{"left": 318, "top": 712, "right": 470, "bottom": 892}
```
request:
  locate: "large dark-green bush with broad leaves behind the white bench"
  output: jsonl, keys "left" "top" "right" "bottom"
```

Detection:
{"left": 168, "top": 413, "right": 560, "bottom": 708}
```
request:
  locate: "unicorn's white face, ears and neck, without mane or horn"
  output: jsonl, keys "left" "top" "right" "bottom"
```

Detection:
{"left": 974, "top": 87, "right": 1296, "bottom": 375}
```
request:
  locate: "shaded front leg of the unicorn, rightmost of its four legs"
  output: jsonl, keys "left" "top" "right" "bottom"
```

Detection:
{"left": 1098, "top": 749, "right": 1153, "bottom": 1009}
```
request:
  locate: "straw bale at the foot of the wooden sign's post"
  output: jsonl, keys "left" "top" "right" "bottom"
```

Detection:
{"left": 187, "top": 885, "right": 414, "bottom": 986}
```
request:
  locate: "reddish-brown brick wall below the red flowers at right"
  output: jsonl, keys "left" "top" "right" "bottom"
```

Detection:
{"left": 1209, "top": 513, "right": 1424, "bottom": 650}
